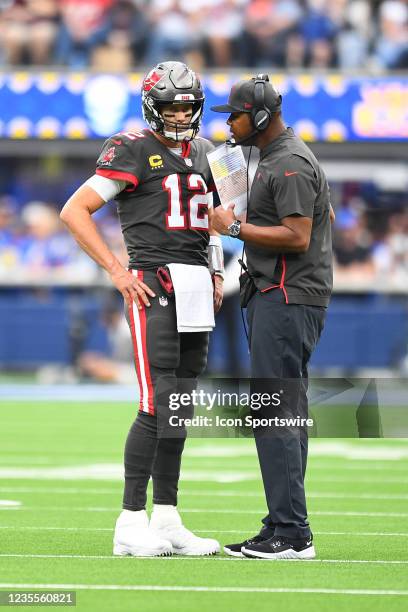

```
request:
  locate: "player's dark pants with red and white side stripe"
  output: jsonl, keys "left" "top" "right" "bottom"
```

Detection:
{"left": 123, "top": 272, "right": 208, "bottom": 510}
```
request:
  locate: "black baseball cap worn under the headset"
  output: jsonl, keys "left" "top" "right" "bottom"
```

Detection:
{"left": 211, "top": 77, "right": 282, "bottom": 113}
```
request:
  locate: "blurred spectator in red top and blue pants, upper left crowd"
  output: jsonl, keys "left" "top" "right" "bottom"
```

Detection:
{"left": 56, "top": 0, "right": 115, "bottom": 68}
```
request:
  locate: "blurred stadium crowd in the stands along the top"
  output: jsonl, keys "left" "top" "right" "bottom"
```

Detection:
{"left": 0, "top": 0, "right": 408, "bottom": 71}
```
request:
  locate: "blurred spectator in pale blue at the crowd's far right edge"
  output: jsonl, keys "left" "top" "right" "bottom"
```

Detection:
{"left": 374, "top": 0, "right": 408, "bottom": 69}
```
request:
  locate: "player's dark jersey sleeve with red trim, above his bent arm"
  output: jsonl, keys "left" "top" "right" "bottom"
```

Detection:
{"left": 95, "top": 134, "right": 140, "bottom": 191}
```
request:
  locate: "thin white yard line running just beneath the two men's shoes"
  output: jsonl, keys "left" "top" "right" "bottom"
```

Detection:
{"left": 0, "top": 553, "right": 408, "bottom": 568}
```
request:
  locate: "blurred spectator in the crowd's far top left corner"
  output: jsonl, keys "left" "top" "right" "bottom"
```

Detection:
{"left": 0, "top": 0, "right": 59, "bottom": 65}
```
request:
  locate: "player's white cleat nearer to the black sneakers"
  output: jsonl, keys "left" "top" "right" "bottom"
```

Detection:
{"left": 150, "top": 505, "right": 220, "bottom": 556}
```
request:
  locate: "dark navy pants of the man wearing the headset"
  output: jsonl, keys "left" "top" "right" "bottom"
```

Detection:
{"left": 247, "top": 289, "right": 326, "bottom": 539}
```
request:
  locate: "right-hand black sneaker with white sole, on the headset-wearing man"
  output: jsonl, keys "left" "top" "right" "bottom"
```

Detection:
{"left": 242, "top": 535, "right": 316, "bottom": 559}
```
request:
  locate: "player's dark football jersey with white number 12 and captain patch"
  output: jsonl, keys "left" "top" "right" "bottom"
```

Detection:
{"left": 96, "top": 129, "right": 214, "bottom": 270}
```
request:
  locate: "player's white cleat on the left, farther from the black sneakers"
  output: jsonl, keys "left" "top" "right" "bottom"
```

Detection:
{"left": 113, "top": 510, "right": 172, "bottom": 557}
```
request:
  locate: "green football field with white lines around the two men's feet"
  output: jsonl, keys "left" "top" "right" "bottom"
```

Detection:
{"left": 0, "top": 401, "right": 408, "bottom": 612}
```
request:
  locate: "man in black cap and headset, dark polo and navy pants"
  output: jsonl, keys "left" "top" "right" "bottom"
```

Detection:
{"left": 211, "top": 75, "right": 334, "bottom": 559}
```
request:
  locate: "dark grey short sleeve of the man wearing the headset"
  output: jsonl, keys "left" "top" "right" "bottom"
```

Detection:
{"left": 269, "top": 155, "right": 318, "bottom": 219}
